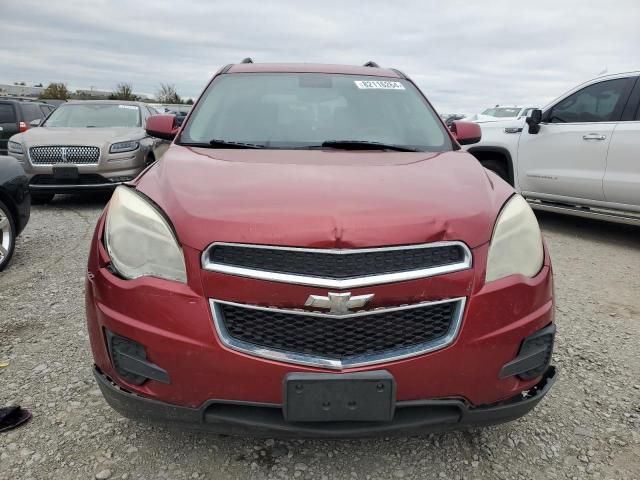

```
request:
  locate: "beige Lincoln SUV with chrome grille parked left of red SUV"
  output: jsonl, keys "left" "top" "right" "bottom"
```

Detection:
{"left": 8, "top": 100, "right": 166, "bottom": 203}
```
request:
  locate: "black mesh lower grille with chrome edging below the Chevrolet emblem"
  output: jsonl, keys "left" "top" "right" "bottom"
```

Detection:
{"left": 213, "top": 299, "right": 463, "bottom": 368}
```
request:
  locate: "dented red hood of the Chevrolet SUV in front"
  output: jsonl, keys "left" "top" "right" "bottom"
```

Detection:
{"left": 137, "top": 145, "right": 513, "bottom": 250}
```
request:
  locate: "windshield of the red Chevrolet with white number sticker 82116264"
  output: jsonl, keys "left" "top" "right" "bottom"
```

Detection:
{"left": 179, "top": 73, "right": 453, "bottom": 151}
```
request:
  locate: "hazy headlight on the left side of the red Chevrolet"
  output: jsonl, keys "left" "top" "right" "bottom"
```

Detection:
{"left": 105, "top": 187, "right": 187, "bottom": 283}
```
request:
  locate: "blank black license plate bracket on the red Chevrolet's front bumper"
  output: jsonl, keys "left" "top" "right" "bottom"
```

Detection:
{"left": 283, "top": 370, "right": 396, "bottom": 422}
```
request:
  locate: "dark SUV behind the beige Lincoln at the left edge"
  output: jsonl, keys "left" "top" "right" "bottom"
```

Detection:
{"left": 0, "top": 97, "right": 56, "bottom": 155}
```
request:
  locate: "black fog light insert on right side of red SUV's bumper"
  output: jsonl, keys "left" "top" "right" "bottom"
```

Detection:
{"left": 500, "top": 324, "right": 556, "bottom": 380}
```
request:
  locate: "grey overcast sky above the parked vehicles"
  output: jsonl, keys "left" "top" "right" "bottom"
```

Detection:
{"left": 0, "top": 0, "right": 640, "bottom": 112}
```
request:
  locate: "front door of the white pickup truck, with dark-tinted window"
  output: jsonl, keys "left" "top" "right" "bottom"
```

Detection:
{"left": 517, "top": 78, "right": 635, "bottom": 201}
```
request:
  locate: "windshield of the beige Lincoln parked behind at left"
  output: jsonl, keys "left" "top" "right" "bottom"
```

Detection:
{"left": 44, "top": 103, "right": 140, "bottom": 128}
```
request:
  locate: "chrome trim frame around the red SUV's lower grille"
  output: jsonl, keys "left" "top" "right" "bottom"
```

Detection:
{"left": 209, "top": 297, "right": 467, "bottom": 370}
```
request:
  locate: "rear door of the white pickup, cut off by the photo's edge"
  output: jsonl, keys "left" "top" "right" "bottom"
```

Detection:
{"left": 603, "top": 76, "right": 640, "bottom": 207}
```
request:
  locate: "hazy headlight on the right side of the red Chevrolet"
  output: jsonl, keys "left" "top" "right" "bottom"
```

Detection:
{"left": 485, "top": 195, "right": 544, "bottom": 282}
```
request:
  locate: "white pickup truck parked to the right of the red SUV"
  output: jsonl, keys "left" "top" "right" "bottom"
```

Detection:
{"left": 468, "top": 71, "right": 640, "bottom": 225}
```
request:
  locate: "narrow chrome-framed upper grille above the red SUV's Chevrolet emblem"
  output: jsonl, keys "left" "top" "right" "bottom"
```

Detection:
{"left": 203, "top": 242, "right": 471, "bottom": 288}
